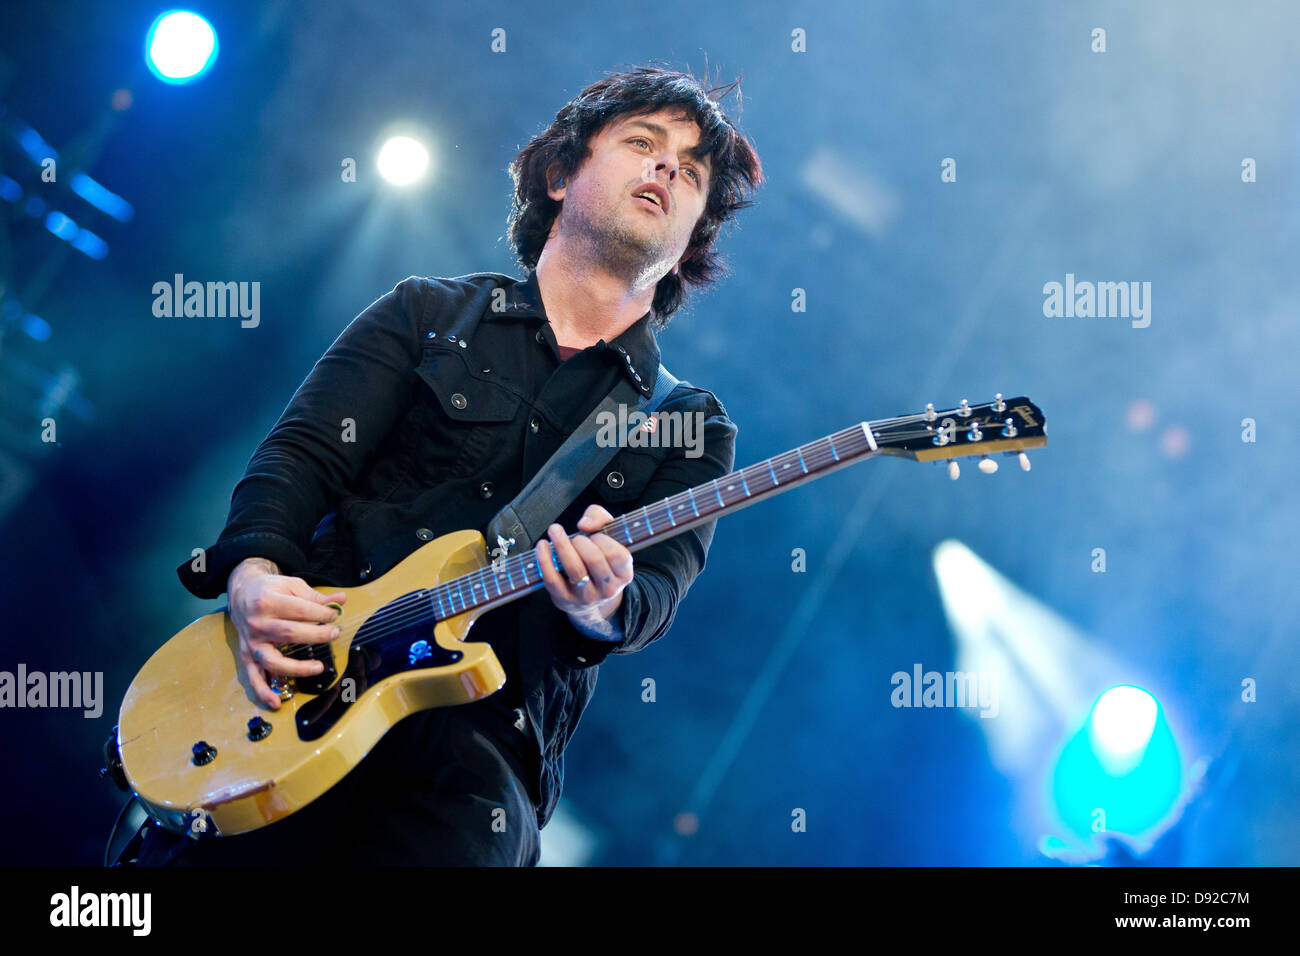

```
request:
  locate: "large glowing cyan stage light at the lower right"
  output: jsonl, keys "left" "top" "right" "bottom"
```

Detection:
{"left": 1052, "top": 685, "right": 1183, "bottom": 839}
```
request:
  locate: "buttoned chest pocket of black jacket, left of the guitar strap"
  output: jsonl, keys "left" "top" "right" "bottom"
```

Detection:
{"left": 416, "top": 346, "right": 521, "bottom": 481}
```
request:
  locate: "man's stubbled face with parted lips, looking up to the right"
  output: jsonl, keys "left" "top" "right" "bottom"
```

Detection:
{"left": 550, "top": 108, "right": 710, "bottom": 287}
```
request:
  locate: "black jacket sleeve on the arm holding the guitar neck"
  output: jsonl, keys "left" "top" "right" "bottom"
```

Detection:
{"left": 563, "top": 393, "right": 738, "bottom": 667}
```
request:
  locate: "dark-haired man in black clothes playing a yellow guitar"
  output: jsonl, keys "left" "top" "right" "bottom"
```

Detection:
{"left": 140, "top": 68, "right": 763, "bottom": 865}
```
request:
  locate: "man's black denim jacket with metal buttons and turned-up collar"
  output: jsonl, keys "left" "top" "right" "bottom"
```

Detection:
{"left": 177, "top": 273, "right": 737, "bottom": 826}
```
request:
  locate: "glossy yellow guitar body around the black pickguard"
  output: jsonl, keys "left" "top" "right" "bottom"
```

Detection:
{"left": 117, "top": 531, "right": 506, "bottom": 835}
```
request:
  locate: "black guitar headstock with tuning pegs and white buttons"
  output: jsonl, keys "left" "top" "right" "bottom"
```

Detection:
{"left": 867, "top": 392, "right": 1048, "bottom": 479}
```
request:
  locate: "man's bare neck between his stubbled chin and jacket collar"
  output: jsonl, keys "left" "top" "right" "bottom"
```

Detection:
{"left": 537, "top": 244, "right": 655, "bottom": 349}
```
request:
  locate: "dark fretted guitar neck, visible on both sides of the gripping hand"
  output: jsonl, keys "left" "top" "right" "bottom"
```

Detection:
{"left": 429, "top": 423, "right": 879, "bottom": 618}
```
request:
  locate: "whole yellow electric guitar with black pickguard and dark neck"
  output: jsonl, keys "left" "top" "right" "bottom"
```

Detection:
{"left": 105, "top": 394, "right": 1047, "bottom": 835}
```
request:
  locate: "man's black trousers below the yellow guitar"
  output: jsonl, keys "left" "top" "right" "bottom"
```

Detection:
{"left": 131, "top": 701, "right": 541, "bottom": 866}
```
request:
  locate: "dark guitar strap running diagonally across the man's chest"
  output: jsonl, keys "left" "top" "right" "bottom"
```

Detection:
{"left": 486, "top": 364, "right": 677, "bottom": 558}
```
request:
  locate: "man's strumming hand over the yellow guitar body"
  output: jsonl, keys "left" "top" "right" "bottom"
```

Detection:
{"left": 226, "top": 558, "right": 347, "bottom": 710}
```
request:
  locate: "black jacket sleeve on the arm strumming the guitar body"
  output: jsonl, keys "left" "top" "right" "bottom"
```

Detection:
{"left": 177, "top": 276, "right": 433, "bottom": 598}
